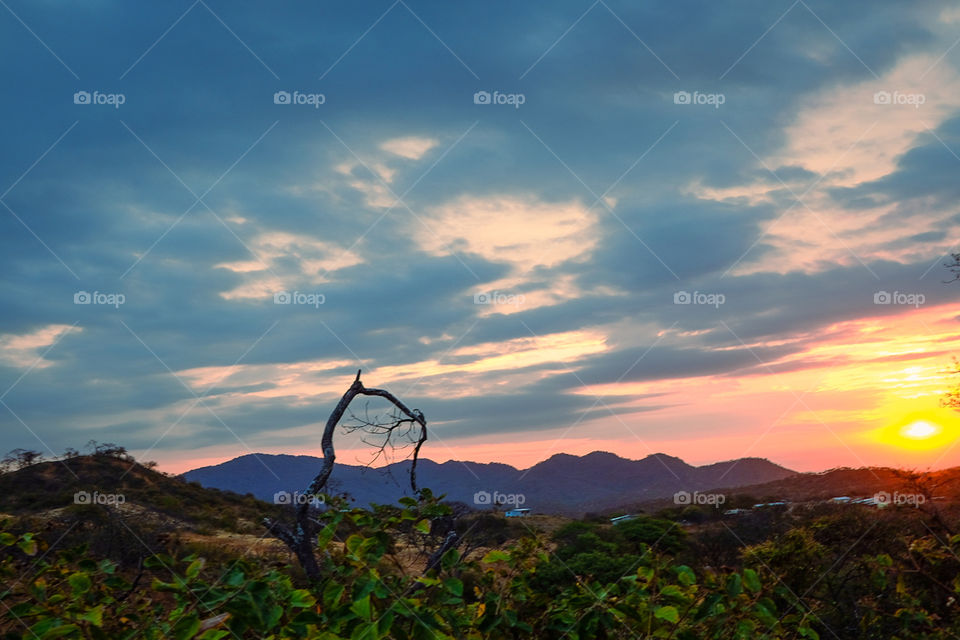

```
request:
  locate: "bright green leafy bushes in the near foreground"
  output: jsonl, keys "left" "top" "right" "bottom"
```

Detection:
{"left": 0, "top": 492, "right": 816, "bottom": 640}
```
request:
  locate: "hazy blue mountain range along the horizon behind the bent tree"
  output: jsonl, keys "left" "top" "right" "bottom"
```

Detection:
{"left": 184, "top": 451, "right": 795, "bottom": 515}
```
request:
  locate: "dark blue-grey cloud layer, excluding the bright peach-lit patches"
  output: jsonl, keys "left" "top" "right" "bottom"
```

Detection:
{"left": 0, "top": 0, "right": 960, "bottom": 460}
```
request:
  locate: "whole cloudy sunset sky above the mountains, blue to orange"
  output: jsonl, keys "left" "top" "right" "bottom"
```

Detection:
{"left": 0, "top": 0, "right": 960, "bottom": 472}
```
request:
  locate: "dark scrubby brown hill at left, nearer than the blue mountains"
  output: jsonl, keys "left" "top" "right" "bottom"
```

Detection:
{"left": 0, "top": 454, "right": 284, "bottom": 567}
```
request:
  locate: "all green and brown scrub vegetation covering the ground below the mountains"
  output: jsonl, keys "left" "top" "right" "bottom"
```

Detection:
{"left": 0, "top": 453, "right": 960, "bottom": 640}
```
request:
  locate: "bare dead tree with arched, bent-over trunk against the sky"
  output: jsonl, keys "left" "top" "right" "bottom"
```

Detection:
{"left": 264, "top": 371, "right": 427, "bottom": 581}
